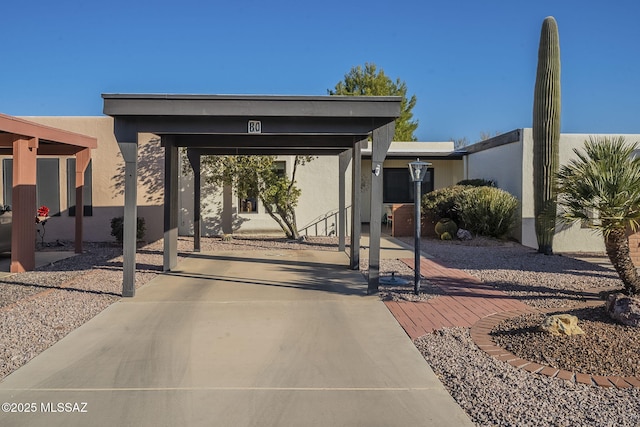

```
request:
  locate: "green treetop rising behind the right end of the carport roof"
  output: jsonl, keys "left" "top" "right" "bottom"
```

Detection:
{"left": 327, "top": 63, "right": 418, "bottom": 141}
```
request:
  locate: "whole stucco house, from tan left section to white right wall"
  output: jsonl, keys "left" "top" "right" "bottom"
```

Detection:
{"left": 6, "top": 117, "right": 640, "bottom": 258}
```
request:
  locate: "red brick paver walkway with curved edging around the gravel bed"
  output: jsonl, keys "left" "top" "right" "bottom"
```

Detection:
{"left": 385, "top": 258, "right": 640, "bottom": 388}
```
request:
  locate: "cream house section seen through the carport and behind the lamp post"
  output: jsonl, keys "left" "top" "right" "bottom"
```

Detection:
{"left": 179, "top": 142, "right": 464, "bottom": 239}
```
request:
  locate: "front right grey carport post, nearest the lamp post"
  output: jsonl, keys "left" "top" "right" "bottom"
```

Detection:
{"left": 367, "top": 122, "right": 395, "bottom": 294}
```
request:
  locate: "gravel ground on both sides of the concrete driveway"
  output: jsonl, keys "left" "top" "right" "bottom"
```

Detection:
{"left": 0, "top": 237, "right": 640, "bottom": 426}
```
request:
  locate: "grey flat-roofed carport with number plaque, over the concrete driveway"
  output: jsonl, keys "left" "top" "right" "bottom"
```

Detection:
{"left": 102, "top": 94, "right": 401, "bottom": 297}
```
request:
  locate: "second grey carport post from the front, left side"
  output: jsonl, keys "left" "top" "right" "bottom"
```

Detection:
{"left": 162, "top": 136, "right": 178, "bottom": 271}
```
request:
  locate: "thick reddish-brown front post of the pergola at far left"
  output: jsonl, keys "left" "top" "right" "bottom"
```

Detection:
{"left": 10, "top": 138, "right": 38, "bottom": 273}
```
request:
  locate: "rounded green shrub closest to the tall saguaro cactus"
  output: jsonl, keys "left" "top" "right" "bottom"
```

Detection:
{"left": 456, "top": 187, "right": 518, "bottom": 238}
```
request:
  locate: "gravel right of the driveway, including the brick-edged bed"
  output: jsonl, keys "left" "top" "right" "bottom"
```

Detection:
{"left": 407, "top": 239, "right": 640, "bottom": 426}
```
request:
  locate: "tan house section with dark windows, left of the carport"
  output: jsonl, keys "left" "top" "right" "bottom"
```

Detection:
{"left": 0, "top": 117, "right": 163, "bottom": 243}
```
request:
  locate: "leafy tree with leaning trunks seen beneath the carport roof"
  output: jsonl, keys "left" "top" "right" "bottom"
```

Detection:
{"left": 202, "top": 156, "right": 314, "bottom": 239}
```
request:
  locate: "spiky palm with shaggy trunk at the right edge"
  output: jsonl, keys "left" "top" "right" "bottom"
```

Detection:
{"left": 557, "top": 137, "right": 640, "bottom": 295}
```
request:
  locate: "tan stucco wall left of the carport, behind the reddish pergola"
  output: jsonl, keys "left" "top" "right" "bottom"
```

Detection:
{"left": 6, "top": 117, "right": 164, "bottom": 242}
